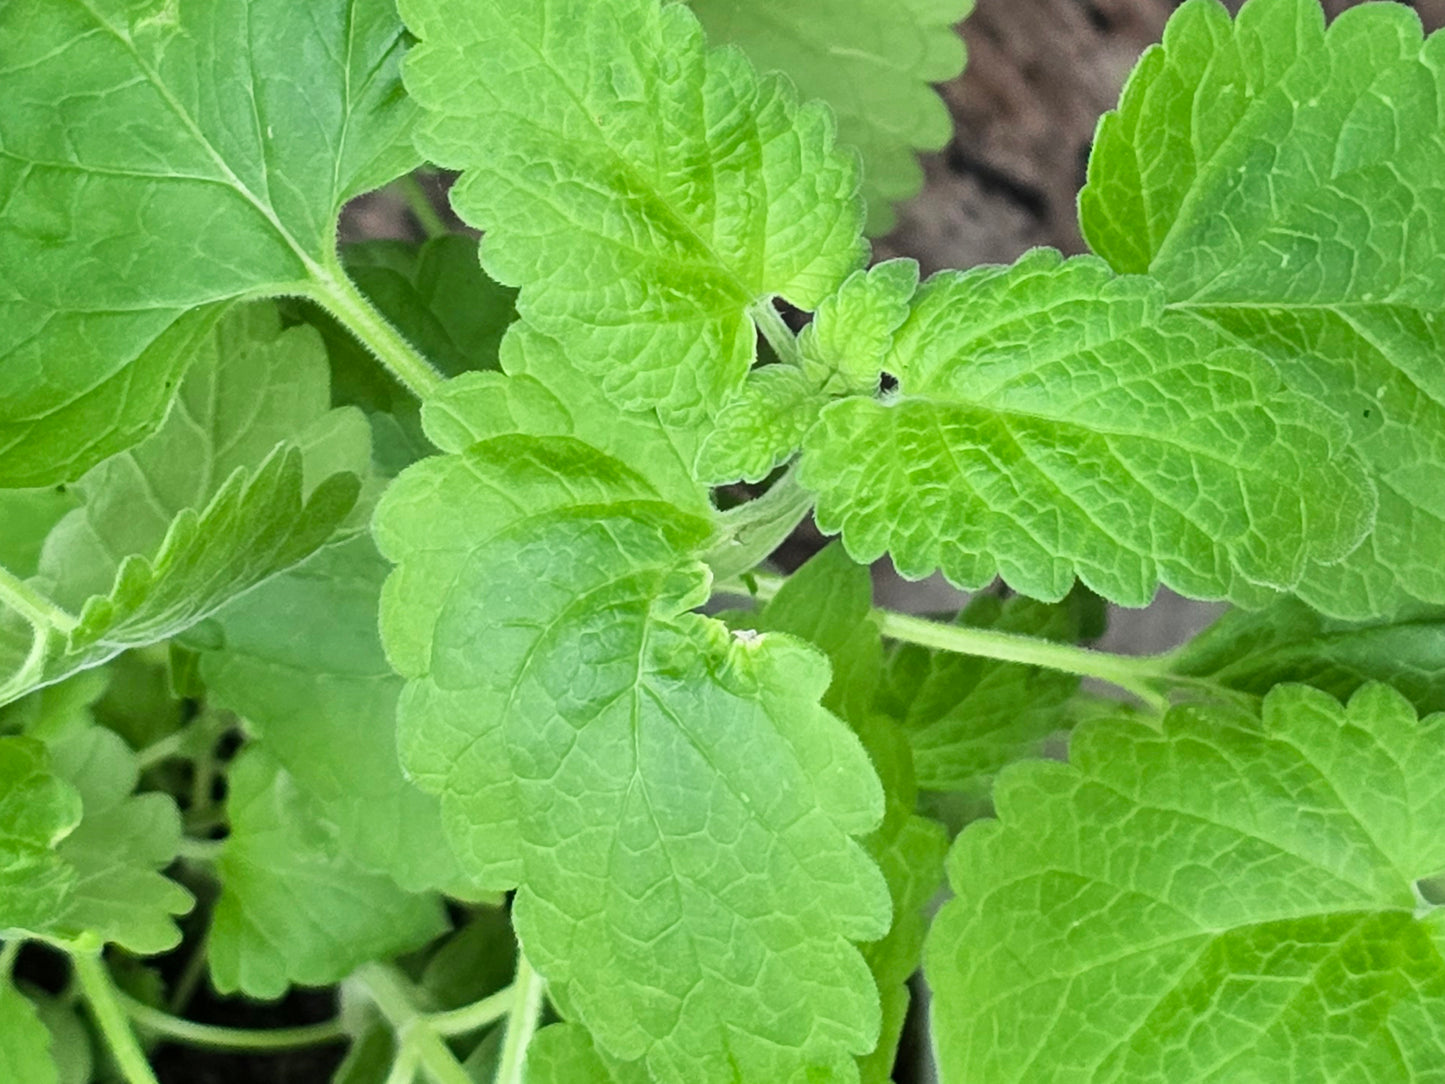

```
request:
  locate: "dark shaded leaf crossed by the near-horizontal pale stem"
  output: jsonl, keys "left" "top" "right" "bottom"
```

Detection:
{"left": 881, "top": 591, "right": 1103, "bottom": 792}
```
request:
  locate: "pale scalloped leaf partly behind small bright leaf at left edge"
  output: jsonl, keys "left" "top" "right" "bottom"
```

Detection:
{"left": 46, "top": 727, "right": 192, "bottom": 955}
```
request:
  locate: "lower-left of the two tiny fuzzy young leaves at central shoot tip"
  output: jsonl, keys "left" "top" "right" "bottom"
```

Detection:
{"left": 696, "top": 364, "right": 828, "bottom": 484}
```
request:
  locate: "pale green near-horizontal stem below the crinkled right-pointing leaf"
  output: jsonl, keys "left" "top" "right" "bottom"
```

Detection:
{"left": 717, "top": 572, "right": 1169, "bottom": 711}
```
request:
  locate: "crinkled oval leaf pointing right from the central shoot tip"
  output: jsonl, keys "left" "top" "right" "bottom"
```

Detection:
{"left": 801, "top": 250, "right": 1373, "bottom": 606}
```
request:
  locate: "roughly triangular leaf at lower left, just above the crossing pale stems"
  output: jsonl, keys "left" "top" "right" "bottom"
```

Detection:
{"left": 207, "top": 749, "right": 447, "bottom": 999}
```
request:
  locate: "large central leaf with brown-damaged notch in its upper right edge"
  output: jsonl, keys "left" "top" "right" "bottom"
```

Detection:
{"left": 376, "top": 436, "right": 889, "bottom": 1081}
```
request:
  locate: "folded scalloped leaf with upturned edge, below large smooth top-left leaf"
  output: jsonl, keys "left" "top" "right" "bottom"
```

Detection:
{"left": 0, "top": 305, "right": 368, "bottom": 701}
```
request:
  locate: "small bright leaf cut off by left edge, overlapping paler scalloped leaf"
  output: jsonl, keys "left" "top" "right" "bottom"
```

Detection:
{"left": 0, "top": 737, "right": 81, "bottom": 929}
